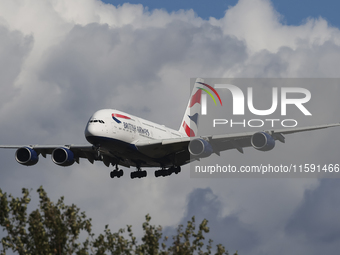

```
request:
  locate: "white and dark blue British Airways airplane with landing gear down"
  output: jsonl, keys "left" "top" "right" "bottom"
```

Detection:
{"left": 0, "top": 78, "right": 340, "bottom": 179}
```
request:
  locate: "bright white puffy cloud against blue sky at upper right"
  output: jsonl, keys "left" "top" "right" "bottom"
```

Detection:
{"left": 211, "top": 0, "right": 340, "bottom": 53}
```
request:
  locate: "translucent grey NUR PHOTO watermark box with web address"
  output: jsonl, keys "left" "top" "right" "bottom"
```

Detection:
{"left": 188, "top": 78, "right": 340, "bottom": 178}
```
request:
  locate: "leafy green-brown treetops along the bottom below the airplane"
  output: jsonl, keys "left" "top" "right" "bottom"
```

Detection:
{"left": 0, "top": 187, "right": 237, "bottom": 255}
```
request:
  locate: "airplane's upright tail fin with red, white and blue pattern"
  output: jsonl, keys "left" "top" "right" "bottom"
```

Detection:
{"left": 179, "top": 78, "right": 204, "bottom": 137}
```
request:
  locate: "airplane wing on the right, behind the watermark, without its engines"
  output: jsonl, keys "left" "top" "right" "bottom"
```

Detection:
{"left": 135, "top": 123, "right": 340, "bottom": 164}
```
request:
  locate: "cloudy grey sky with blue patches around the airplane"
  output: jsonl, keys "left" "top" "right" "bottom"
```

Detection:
{"left": 0, "top": 0, "right": 340, "bottom": 255}
